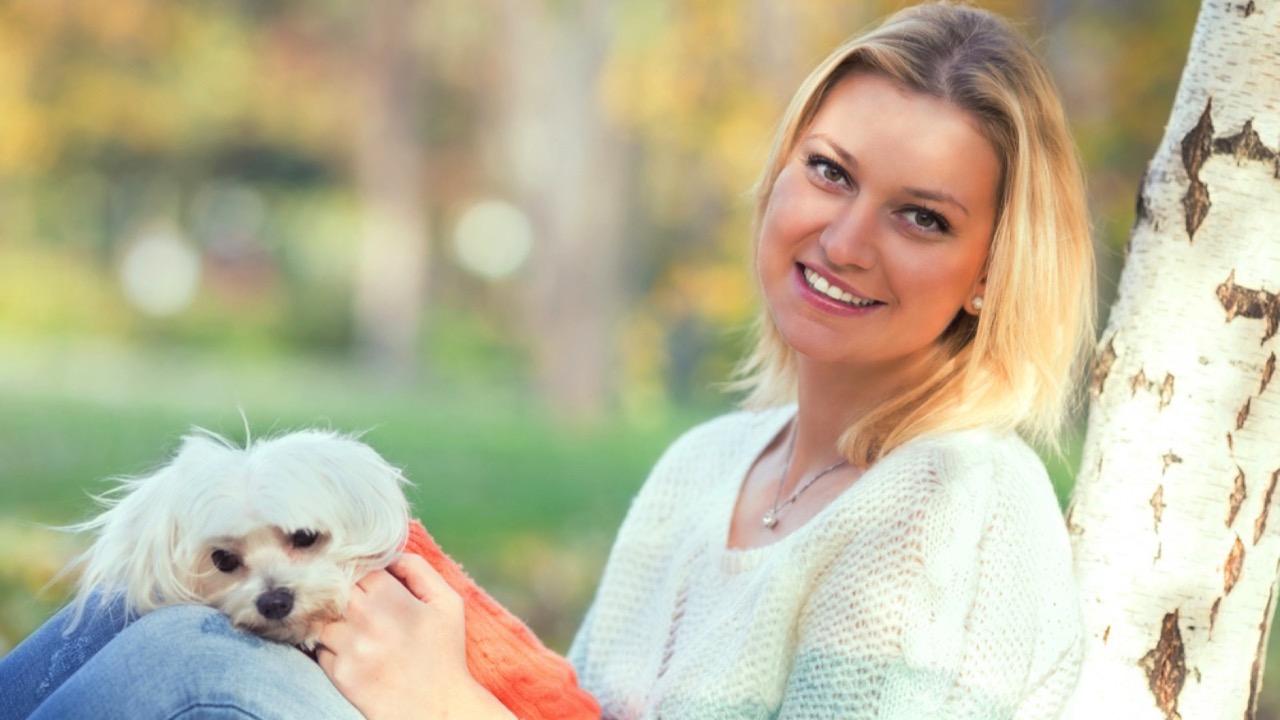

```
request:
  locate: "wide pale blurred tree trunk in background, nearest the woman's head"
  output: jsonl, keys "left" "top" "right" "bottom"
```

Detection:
{"left": 494, "top": 0, "right": 634, "bottom": 416}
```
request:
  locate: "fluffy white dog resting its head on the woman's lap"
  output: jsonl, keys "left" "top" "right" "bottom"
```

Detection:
{"left": 61, "top": 430, "right": 408, "bottom": 650}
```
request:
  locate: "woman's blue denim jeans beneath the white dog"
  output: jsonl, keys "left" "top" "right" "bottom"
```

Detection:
{"left": 0, "top": 603, "right": 361, "bottom": 720}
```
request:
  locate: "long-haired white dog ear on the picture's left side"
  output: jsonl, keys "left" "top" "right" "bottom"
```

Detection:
{"left": 68, "top": 432, "right": 241, "bottom": 626}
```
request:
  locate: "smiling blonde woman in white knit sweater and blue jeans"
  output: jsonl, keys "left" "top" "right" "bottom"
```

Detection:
{"left": 5, "top": 5, "right": 1093, "bottom": 719}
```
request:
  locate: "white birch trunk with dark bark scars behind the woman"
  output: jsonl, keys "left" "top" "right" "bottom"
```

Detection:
{"left": 1068, "top": 0, "right": 1280, "bottom": 720}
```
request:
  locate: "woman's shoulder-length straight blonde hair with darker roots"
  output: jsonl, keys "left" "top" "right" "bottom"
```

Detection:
{"left": 735, "top": 4, "right": 1094, "bottom": 464}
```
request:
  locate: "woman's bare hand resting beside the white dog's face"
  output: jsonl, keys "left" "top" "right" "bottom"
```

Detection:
{"left": 316, "top": 555, "right": 512, "bottom": 720}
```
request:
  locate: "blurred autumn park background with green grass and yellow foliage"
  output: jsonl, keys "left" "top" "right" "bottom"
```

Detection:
{"left": 0, "top": 0, "right": 1259, "bottom": 717}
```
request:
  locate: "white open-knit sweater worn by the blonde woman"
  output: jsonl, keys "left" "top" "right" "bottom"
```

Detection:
{"left": 570, "top": 407, "right": 1083, "bottom": 720}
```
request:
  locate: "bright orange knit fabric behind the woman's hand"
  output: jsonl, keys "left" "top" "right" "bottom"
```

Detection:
{"left": 404, "top": 520, "right": 600, "bottom": 720}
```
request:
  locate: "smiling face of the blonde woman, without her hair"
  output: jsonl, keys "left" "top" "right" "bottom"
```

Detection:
{"left": 756, "top": 72, "right": 1000, "bottom": 373}
